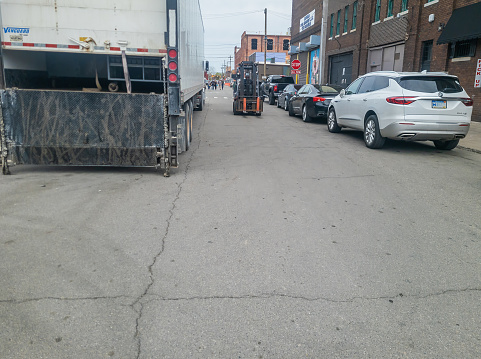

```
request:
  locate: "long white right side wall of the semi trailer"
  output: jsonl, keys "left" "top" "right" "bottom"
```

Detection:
{"left": 178, "top": 0, "right": 204, "bottom": 100}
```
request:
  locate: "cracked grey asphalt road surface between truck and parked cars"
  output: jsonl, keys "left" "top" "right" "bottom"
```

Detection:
{"left": 0, "top": 88, "right": 481, "bottom": 359}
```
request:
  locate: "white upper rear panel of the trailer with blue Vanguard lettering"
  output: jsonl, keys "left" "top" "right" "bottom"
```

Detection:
{"left": 0, "top": 0, "right": 167, "bottom": 56}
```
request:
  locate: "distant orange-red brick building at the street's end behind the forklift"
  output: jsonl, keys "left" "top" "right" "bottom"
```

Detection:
{"left": 234, "top": 31, "right": 291, "bottom": 72}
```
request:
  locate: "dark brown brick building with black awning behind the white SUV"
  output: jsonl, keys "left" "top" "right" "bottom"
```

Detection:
{"left": 324, "top": 0, "right": 481, "bottom": 121}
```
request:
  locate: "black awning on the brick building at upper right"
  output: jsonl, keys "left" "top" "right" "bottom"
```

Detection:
{"left": 437, "top": 2, "right": 481, "bottom": 45}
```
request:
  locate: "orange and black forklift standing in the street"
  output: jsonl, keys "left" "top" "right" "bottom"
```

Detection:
{"left": 232, "top": 61, "right": 264, "bottom": 116}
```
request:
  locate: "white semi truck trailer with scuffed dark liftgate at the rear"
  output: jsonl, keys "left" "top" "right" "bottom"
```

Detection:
{"left": 0, "top": 0, "right": 206, "bottom": 176}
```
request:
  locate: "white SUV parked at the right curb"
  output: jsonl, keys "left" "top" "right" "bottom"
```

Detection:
{"left": 327, "top": 71, "right": 473, "bottom": 150}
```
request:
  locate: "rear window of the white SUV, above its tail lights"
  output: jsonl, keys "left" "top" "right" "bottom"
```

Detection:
{"left": 399, "top": 76, "right": 463, "bottom": 93}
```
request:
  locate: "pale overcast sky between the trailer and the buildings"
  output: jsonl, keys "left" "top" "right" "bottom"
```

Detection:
{"left": 199, "top": 0, "right": 292, "bottom": 72}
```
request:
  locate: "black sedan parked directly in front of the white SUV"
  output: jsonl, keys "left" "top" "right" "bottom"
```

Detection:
{"left": 289, "top": 84, "right": 342, "bottom": 122}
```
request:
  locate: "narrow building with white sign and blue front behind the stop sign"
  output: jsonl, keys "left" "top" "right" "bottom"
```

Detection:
{"left": 289, "top": 0, "right": 328, "bottom": 84}
